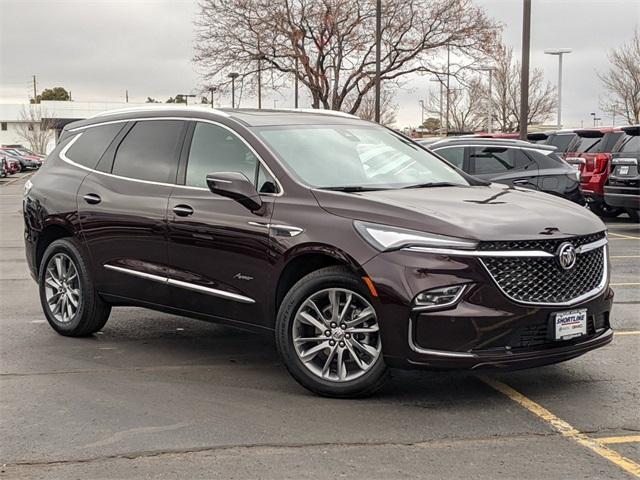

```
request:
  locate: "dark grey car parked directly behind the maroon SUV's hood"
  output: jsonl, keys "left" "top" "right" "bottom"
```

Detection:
{"left": 428, "top": 137, "right": 585, "bottom": 205}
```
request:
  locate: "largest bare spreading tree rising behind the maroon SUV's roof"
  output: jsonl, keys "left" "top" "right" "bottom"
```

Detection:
{"left": 194, "top": 0, "right": 498, "bottom": 113}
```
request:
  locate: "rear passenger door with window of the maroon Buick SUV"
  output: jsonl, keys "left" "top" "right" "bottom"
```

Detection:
{"left": 78, "top": 119, "right": 187, "bottom": 304}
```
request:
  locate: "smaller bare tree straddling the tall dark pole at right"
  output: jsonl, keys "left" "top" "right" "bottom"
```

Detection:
{"left": 488, "top": 45, "right": 556, "bottom": 132}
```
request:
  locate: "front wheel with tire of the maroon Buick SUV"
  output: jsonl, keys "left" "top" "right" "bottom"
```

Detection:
{"left": 276, "top": 267, "right": 388, "bottom": 398}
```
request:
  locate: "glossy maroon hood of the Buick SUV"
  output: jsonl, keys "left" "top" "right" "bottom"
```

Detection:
{"left": 313, "top": 184, "right": 606, "bottom": 240}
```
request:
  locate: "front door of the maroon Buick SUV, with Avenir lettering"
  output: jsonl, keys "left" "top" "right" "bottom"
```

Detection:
{"left": 168, "top": 121, "right": 279, "bottom": 326}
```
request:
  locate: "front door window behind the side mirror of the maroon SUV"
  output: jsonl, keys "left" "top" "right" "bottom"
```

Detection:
{"left": 185, "top": 122, "right": 268, "bottom": 193}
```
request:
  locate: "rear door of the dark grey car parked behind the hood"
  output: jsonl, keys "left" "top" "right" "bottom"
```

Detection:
{"left": 467, "top": 145, "right": 538, "bottom": 190}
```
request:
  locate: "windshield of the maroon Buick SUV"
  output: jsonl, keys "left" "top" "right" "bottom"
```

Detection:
{"left": 258, "top": 125, "right": 469, "bottom": 190}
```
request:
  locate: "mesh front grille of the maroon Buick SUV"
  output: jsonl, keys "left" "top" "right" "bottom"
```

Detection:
{"left": 481, "top": 244, "right": 606, "bottom": 304}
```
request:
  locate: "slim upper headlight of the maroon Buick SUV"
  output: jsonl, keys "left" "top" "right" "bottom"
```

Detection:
{"left": 353, "top": 220, "right": 477, "bottom": 251}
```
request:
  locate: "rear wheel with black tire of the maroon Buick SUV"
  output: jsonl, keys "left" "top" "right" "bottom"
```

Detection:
{"left": 38, "top": 238, "right": 111, "bottom": 337}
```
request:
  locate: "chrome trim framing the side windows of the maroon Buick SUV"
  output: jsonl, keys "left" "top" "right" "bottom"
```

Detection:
{"left": 58, "top": 117, "right": 284, "bottom": 197}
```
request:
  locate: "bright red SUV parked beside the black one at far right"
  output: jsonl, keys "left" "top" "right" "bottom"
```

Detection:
{"left": 565, "top": 128, "right": 624, "bottom": 217}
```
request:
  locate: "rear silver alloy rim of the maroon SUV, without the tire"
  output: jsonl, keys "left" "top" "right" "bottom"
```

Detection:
{"left": 44, "top": 253, "right": 81, "bottom": 323}
